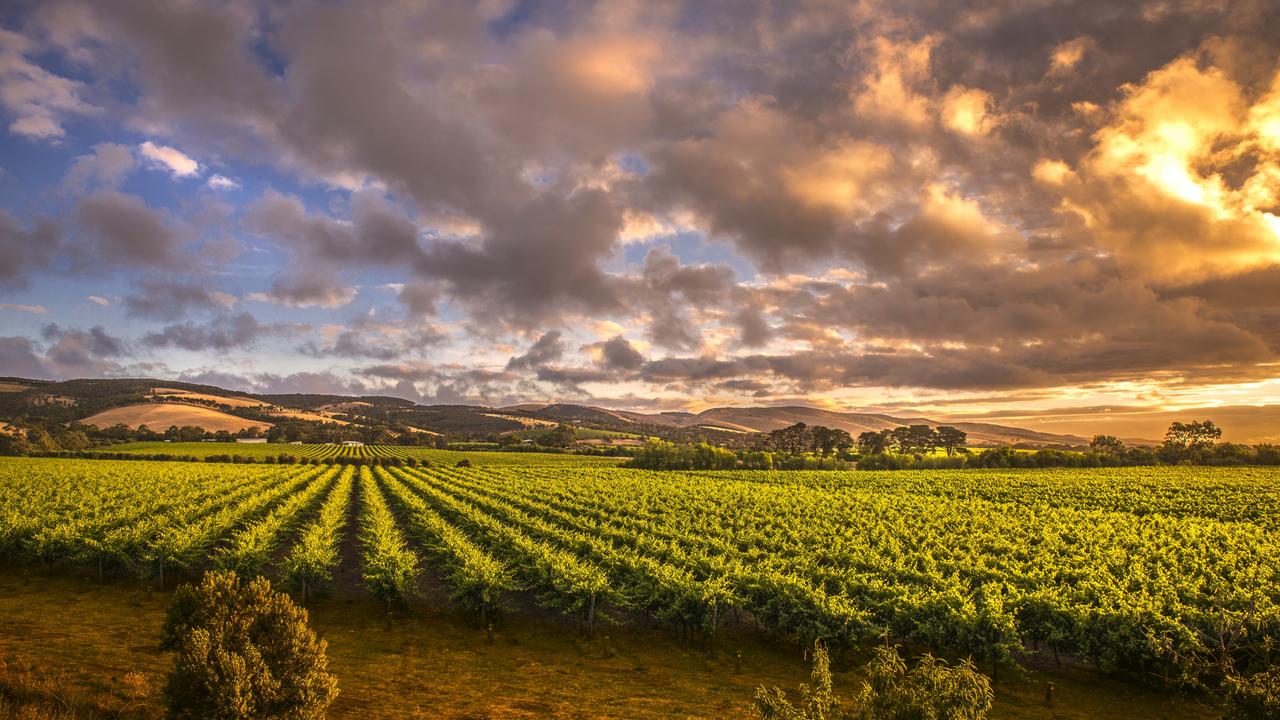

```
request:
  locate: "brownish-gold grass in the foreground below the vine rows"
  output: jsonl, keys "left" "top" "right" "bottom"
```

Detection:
{"left": 0, "top": 566, "right": 1215, "bottom": 720}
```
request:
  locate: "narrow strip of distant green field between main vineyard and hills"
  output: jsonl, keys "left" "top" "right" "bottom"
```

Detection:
{"left": 102, "top": 441, "right": 626, "bottom": 466}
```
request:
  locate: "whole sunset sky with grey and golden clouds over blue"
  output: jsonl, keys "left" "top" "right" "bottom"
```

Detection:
{"left": 0, "top": 0, "right": 1280, "bottom": 438}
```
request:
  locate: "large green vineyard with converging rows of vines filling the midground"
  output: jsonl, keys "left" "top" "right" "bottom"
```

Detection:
{"left": 0, "top": 446, "right": 1280, "bottom": 684}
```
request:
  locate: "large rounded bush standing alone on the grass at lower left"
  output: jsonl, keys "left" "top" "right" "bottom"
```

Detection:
{"left": 161, "top": 571, "right": 338, "bottom": 720}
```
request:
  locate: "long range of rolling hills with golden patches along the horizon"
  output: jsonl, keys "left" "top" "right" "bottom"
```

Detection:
{"left": 0, "top": 378, "right": 1141, "bottom": 446}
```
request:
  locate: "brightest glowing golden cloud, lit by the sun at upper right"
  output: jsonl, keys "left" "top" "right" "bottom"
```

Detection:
{"left": 1033, "top": 56, "right": 1280, "bottom": 281}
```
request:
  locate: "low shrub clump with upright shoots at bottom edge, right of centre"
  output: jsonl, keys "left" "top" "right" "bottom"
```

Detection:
{"left": 755, "top": 642, "right": 995, "bottom": 720}
